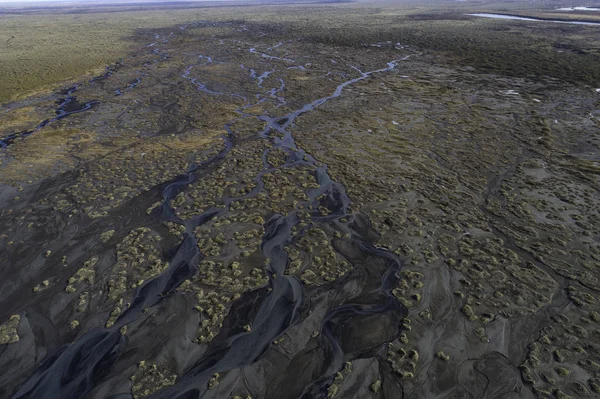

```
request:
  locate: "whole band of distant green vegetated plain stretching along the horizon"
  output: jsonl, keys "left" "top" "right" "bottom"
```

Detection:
{"left": 0, "top": 2, "right": 600, "bottom": 103}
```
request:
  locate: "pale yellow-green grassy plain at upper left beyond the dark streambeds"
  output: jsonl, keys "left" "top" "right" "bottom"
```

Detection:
{"left": 0, "top": 10, "right": 227, "bottom": 103}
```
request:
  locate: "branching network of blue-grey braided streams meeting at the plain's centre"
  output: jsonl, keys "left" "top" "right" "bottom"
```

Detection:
{"left": 12, "top": 27, "right": 408, "bottom": 399}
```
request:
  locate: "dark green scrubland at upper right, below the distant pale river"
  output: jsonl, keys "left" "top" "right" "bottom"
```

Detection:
{"left": 302, "top": 15, "right": 600, "bottom": 85}
